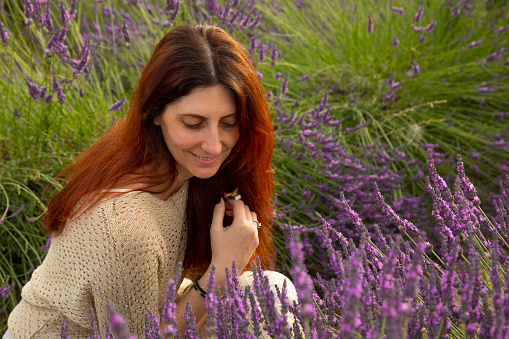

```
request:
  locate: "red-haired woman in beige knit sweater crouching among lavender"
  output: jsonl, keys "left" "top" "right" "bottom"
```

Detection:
{"left": 8, "top": 25, "right": 296, "bottom": 339}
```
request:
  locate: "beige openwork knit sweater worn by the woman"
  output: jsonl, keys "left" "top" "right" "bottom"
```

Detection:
{"left": 8, "top": 182, "right": 188, "bottom": 339}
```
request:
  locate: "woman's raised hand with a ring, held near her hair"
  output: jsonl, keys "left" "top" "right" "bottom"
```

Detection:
{"left": 210, "top": 198, "right": 258, "bottom": 272}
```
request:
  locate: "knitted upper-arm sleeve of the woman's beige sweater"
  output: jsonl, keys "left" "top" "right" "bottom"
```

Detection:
{"left": 91, "top": 200, "right": 169, "bottom": 338}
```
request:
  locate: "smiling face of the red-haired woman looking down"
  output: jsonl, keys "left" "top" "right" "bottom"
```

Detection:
{"left": 154, "top": 84, "right": 239, "bottom": 182}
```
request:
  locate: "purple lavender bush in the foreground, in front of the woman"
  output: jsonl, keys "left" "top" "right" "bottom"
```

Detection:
{"left": 51, "top": 152, "right": 509, "bottom": 338}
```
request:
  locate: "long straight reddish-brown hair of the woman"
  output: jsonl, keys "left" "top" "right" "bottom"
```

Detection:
{"left": 44, "top": 24, "right": 275, "bottom": 271}
